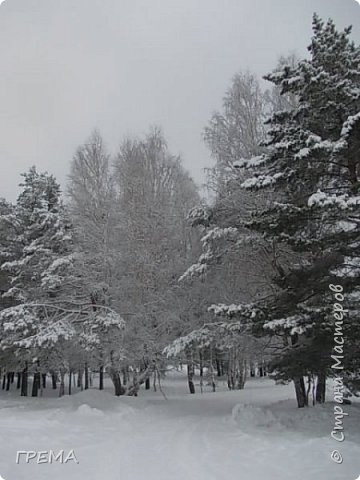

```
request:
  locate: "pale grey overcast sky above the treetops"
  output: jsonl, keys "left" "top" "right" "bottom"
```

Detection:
{"left": 0, "top": 0, "right": 360, "bottom": 200}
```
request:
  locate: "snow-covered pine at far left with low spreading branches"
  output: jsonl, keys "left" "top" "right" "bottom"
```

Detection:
{"left": 0, "top": 167, "right": 124, "bottom": 395}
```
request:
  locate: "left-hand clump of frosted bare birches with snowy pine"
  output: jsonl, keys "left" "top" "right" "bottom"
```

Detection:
{"left": 0, "top": 129, "right": 199, "bottom": 396}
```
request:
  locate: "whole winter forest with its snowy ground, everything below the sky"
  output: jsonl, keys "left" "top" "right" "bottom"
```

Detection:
{"left": 0, "top": 10, "right": 360, "bottom": 480}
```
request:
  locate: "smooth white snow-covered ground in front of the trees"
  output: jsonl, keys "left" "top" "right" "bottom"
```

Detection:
{"left": 0, "top": 372, "right": 360, "bottom": 480}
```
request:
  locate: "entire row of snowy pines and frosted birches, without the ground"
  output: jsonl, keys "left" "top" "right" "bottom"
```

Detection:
{"left": 0, "top": 15, "right": 360, "bottom": 407}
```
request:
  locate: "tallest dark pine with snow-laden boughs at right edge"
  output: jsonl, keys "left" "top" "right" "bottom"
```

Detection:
{"left": 213, "top": 15, "right": 360, "bottom": 407}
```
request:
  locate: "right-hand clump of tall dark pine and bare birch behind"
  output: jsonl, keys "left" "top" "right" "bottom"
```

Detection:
{"left": 169, "top": 15, "right": 360, "bottom": 407}
